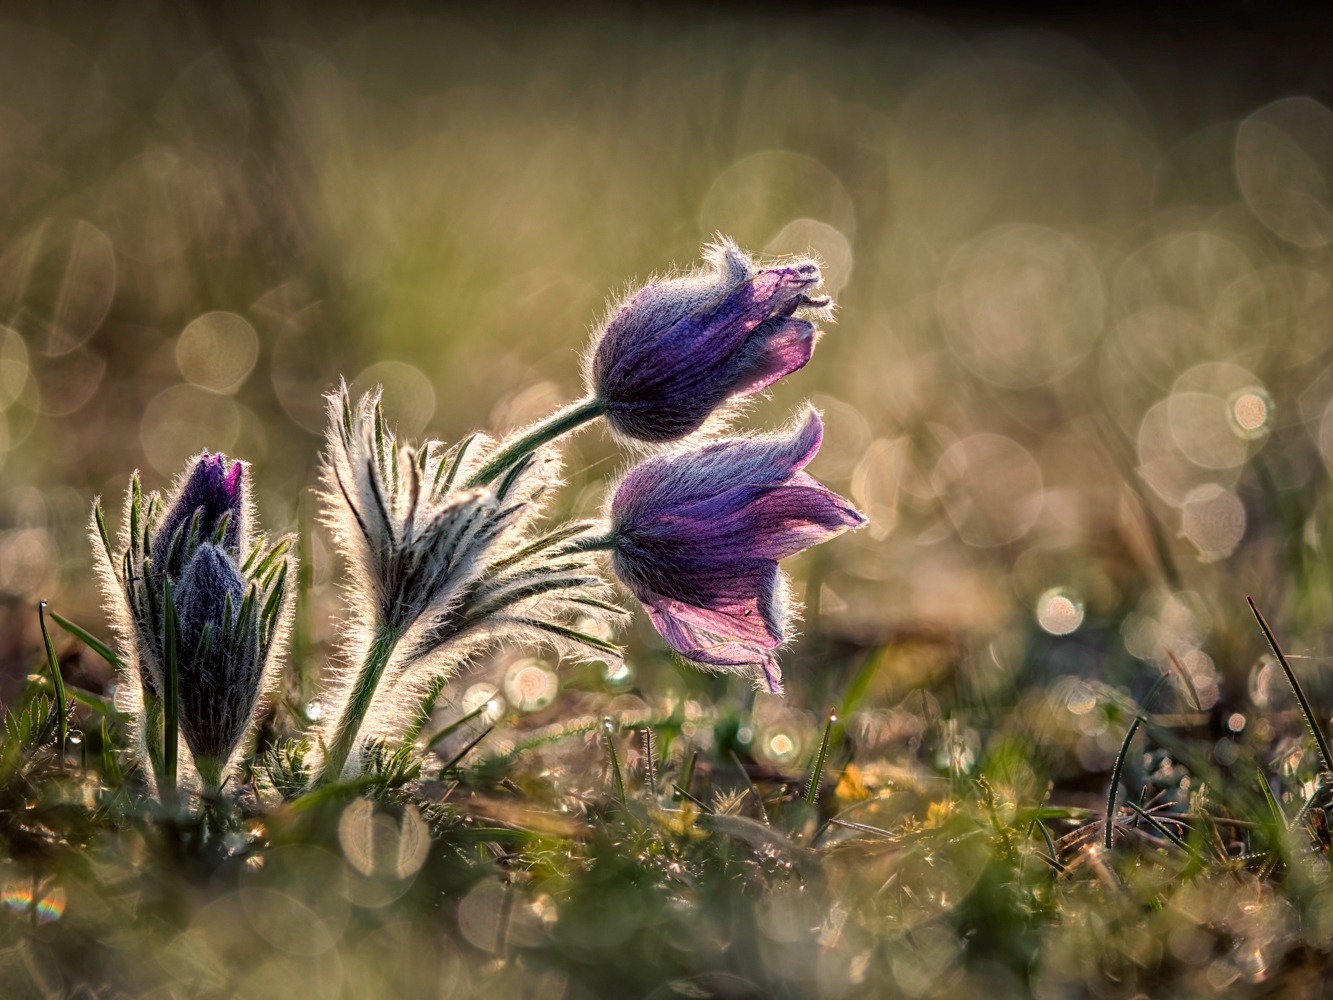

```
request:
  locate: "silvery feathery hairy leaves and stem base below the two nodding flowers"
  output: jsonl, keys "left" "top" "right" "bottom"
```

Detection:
{"left": 316, "top": 384, "right": 624, "bottom": 780}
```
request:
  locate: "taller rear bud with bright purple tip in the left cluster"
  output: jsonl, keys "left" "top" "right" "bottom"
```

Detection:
{"left": 151, "top": 452, "right": 245, "bottom": 577}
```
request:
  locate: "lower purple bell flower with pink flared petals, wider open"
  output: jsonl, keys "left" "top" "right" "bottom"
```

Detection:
{"left": 611, "top": 409, "right": 865, "bottom": 692}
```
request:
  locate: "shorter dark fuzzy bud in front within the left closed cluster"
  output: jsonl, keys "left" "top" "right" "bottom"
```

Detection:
{"left": 175, "top": 543, "right": 254, "bottom": 761}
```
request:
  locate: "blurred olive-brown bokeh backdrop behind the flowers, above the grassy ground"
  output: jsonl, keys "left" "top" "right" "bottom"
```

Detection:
{"left": 0, "top": 3, "right": 1333, "bottom": 752}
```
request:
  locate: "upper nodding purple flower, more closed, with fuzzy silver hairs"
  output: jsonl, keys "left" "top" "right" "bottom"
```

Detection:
{"left": 585, "top": 240, "right": 832, "bottom": 441}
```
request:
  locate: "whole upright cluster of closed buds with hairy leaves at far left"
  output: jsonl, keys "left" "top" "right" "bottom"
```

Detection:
{"left": 92, "top": 452, "right": 295, "bottom": 792}
